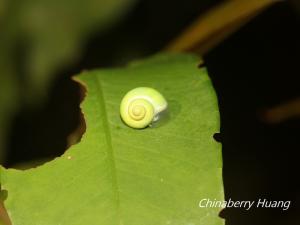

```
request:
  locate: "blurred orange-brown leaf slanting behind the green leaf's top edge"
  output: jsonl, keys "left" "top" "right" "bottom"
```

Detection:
{"left": 167, "top": 0, "right": 278, "bottom": 55}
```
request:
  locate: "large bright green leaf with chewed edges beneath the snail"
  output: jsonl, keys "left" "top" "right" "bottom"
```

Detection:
{"left": 1, "top": 55, "right": 224, "bottom": 225}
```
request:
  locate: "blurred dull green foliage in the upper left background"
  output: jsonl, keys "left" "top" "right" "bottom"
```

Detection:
{"left": 0, "top": 0, "right": 135, "bottom": 161}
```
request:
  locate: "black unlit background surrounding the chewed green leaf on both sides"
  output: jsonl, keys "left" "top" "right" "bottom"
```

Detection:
{"left": 5, "top": 0, "right": 300, "bottom": 225}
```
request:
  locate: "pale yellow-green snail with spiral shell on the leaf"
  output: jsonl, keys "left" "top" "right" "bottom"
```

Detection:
{"left": 120, "top": 87, "right": 168, "bottom": 129}
